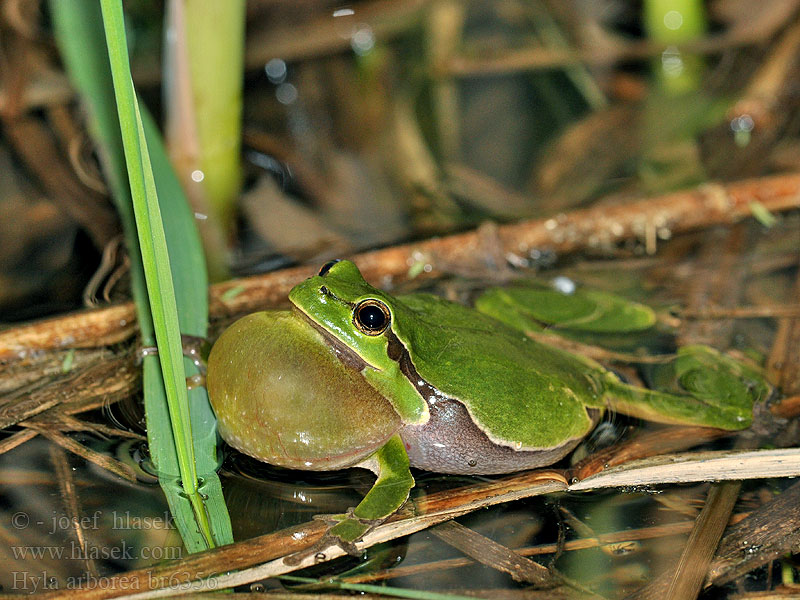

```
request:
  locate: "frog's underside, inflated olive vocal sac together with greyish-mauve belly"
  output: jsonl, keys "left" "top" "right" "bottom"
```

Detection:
{"left": 207, "top": 311, "right": 599, "bottom": 474}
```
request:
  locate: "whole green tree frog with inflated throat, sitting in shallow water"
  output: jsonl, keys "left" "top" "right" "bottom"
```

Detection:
{"left": 207, "top": 260, "right": 768, "bottom": 544}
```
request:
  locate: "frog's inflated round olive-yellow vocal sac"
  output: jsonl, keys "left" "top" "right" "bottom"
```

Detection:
{"left": 206, "top": 311, "right": 401, "bottom": 470}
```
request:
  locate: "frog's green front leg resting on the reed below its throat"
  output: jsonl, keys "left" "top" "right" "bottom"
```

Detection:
{"left": 314, "top": 435, "right": 414, "bottom": 554}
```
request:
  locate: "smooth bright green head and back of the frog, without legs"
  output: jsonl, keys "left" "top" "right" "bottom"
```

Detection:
{"left": 289, "top": 261, "right": 606, "bottom": 451}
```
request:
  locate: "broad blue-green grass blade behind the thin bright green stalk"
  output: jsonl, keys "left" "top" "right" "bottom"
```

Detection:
{"left": 50, "top": 0, "right": 233, "bottom": 552}
